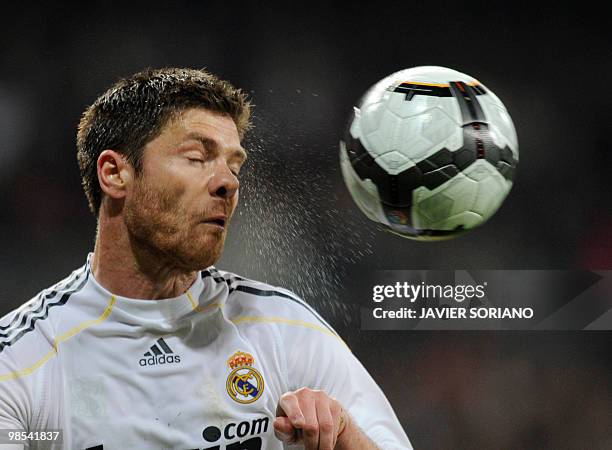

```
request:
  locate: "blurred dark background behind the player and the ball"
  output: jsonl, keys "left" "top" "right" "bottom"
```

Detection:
{"left": 0, "top": 2, "right": 612, "bottom": 449}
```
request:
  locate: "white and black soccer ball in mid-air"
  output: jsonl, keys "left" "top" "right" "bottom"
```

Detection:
{"left": 340, "top": 66, "right": 518, "bottom": 240}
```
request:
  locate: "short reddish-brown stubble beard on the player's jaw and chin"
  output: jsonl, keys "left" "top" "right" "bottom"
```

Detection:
{"left": 125, "top": 179, "right": 227, "bottom": 271}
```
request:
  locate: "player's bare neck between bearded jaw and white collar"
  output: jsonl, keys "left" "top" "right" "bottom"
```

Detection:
{"left": 91, "top": 209, "right": 197, "bottom": 300}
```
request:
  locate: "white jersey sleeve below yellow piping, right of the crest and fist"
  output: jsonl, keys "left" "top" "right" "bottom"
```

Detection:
{"left": 283, "top": 315, "right": 412, "bottom": 450}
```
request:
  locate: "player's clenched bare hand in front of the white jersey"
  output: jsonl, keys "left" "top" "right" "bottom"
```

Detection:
{"left": 274, "top": 387, "right": 349, "bottom": 450}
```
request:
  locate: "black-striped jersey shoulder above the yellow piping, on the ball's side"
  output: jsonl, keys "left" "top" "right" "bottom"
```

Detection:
{"left": 208, "top": 267, "right": 335, "bottom": 334}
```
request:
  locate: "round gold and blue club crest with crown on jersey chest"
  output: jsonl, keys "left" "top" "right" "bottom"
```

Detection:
{"left": 226, "top": 351, "right": 264, "bottom": 403}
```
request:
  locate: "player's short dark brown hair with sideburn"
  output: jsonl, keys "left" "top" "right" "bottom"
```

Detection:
{"left": 77, "top": 68, "right": 251, "bottom": 216}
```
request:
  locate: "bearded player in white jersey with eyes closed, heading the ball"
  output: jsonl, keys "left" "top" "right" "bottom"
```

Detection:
{"left": 0, "top": 69, "right": 410, "bottom": 450}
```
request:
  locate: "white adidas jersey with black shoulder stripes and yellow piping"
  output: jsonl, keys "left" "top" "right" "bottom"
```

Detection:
{"left": 0, "top": 255, "right": 412, "bottom": 450}
